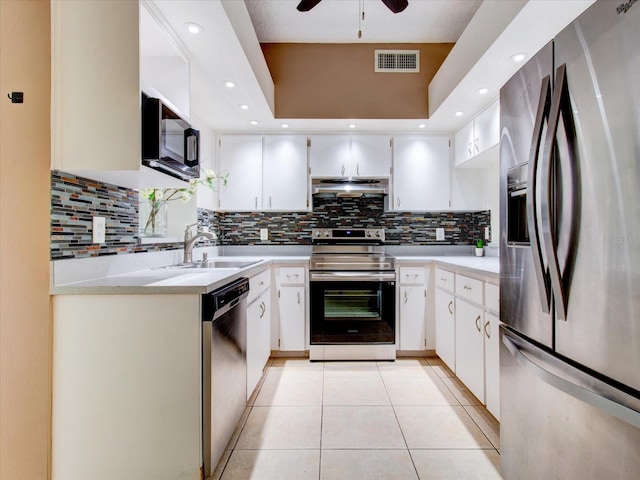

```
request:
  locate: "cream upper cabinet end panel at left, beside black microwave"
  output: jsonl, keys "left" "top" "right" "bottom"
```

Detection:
{"left": 51, "top": 0, "right": 186, "bottom": 187}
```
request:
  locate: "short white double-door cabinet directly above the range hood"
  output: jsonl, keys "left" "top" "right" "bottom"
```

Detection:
{"left": 309, "top": 135, "right": 391, "bottom": 177}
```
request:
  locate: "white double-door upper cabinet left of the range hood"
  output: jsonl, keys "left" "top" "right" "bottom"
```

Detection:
{"left": 218, "top": 135, "right": 309, "bottom": 211}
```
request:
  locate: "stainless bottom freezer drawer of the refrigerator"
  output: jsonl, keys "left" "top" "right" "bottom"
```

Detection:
{"left": 500, "top": 328, "right": 640, "bottom": 480}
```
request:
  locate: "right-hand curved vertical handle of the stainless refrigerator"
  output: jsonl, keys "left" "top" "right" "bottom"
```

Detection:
{"left": 541, "top": 64, "right": 573, "bottom": 320}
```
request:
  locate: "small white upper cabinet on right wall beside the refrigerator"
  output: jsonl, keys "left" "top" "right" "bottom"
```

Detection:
{"left": 455, "top": 100, "right": 500, "bottom": 168}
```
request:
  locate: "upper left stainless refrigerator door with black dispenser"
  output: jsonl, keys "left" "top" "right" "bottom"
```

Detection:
{"left": 500, "top": 44, "right": 553, "bottom": 347}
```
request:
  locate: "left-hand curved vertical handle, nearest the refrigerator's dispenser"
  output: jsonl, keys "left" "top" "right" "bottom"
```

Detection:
{"left": 527, "top": 75, "right": 551, "bottom": 313}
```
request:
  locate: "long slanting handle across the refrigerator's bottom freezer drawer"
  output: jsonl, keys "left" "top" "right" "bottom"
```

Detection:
{"left": 500, "top": 326, "right": 640, "bottom": 428}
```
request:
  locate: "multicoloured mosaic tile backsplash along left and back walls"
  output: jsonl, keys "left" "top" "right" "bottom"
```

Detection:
{"left": 51, "top": 171, "right": 491, "bottom": 260}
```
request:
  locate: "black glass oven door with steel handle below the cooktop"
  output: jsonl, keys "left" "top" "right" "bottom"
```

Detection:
{"left": 310, "top": 271, "right": 396, "bottom": 345}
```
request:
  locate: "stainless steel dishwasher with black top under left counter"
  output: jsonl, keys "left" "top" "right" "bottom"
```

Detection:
{"left": 202, "top": 278, "right": 249, "bottom": 477}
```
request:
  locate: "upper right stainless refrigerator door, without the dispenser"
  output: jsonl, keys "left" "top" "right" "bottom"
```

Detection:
{"left": 547, "top": 1, "right": 640, "bottom": 391}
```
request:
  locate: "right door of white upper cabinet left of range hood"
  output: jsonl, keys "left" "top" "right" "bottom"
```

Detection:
{"left": 262, "top": 135, "right": 308, "bottom": 211}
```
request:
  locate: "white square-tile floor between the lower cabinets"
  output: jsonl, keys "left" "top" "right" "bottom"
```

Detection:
{"left": 212, "top": 358, "right": 501, "bottom": 480}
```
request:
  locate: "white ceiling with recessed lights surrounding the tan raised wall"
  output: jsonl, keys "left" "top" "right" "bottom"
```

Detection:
{"left": 140, "top": 0, "right": 594, "bottom": 132}
